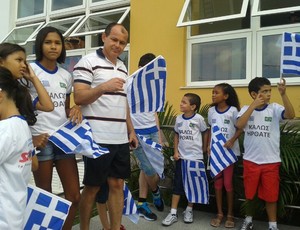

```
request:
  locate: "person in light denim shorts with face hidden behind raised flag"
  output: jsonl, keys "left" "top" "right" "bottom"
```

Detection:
{"left": 131, "top": 53, "right": 164, "bottom": 220}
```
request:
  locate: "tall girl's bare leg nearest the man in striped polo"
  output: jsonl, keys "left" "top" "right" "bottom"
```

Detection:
{"left": 55, "top": 158, "right": 80, "bottom": 229}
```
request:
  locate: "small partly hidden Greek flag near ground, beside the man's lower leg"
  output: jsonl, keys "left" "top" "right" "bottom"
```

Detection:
{"left": 123, "top": 183, "right": 139, "bottom": 224}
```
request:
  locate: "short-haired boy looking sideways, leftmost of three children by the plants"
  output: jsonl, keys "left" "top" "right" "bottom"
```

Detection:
{"left": 162, "top": 93, "right": 207, "bottom": 226}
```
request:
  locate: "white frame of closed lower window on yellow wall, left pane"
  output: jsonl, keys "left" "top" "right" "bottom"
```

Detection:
{"left": 183, "top": 30, "right": 253, "bottom": 88}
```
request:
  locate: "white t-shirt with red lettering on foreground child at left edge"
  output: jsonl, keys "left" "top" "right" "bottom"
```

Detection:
{"left": 0, "top": 116, "right": 33, "bottom": 230}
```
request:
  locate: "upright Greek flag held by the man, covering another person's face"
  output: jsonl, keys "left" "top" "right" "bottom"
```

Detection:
{"left": 127, "top": 56, "right": 167, "bottom": 113}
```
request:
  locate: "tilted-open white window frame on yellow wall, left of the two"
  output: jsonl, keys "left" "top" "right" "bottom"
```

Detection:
{"left": 176, "top": 0, "right": 250, "bottom": 27}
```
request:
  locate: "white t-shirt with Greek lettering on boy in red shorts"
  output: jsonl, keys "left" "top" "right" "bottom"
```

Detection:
{"left": 238, "top": 103, "right": 284, "bottom": 164}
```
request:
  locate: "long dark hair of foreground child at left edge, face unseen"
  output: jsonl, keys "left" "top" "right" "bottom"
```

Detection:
{"left": 0, "top": 67, "right": 36, "bottom": 125}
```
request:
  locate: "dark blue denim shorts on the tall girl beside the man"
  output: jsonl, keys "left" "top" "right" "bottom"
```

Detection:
{"left": 36, "top": 141, "right": 75, "bottom": 161}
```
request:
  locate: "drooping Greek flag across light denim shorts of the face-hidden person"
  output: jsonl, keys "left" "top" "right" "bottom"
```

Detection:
{"left": 137, "top": 135, "right": 164, "bottom": 179}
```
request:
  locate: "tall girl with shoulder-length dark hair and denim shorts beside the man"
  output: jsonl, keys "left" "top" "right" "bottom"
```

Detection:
{"left": 30, "top": 27, "right": 82, "bottom": 229}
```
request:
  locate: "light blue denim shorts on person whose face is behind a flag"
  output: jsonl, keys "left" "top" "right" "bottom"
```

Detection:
{"left": 133, "top": 132, "right": 158, "bottom": 176}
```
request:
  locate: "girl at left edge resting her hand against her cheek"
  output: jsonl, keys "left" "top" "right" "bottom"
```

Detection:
{"left": 0, "top": 43, "right": 54, "bottom": 150}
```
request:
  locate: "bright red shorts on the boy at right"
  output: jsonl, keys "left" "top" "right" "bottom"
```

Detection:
{"left": 243, "top": 160, "right": 280, "bottom": 203}
